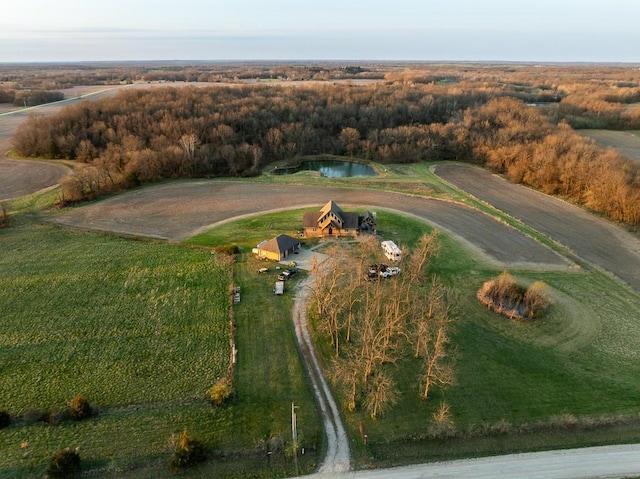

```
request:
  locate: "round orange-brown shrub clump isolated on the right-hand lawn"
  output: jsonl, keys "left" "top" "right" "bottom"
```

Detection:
{"left": 477, "top": 271, "right": 549, "bottom": 319}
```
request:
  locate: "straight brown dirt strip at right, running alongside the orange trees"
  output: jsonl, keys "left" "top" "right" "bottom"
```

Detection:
{"left": 435, "top": 164, "right": 640, "bottom": 292}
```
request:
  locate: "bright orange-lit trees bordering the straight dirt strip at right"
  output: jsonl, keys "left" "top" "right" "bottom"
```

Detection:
{"left": 458, "top": 98, "right": 640, "bottom": 226}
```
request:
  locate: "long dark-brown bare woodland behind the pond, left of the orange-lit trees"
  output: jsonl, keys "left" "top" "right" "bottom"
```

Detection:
{"left": 13, "top": 84, "right": 487, "bottom": 201}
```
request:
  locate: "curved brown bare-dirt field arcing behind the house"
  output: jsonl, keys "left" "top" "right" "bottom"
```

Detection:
{"left": 53, "top": 181, "right": 568, "bottom": 268}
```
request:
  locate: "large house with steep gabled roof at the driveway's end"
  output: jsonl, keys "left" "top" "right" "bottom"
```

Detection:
{"left": 302, "top": 200, "right": 376, "bottom": 238}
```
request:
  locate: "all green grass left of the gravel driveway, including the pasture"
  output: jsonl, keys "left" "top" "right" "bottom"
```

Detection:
{"left": 0, "top": 222, "right": 322, "bottom": 478}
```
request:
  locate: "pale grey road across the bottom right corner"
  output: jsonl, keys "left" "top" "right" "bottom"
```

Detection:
{"left": 298, "top": 444, "right": 640, "bottom": 479}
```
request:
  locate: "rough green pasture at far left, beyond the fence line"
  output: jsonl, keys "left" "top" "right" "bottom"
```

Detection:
{"left": 0, "top": 225, "right": 230, "bottom": 477}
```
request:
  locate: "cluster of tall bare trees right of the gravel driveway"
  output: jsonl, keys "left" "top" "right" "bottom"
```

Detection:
{"left": 310, "top": 233, "right": 455, "bottom": 418}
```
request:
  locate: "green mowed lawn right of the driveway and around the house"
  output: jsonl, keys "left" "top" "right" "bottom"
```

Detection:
{"left": 201, "top": 210, "right": 640, "bottom": 467}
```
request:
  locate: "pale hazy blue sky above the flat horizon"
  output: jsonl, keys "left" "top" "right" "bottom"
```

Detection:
{"left": 0, "top": 0, "right": 640, "bottom": 63}
